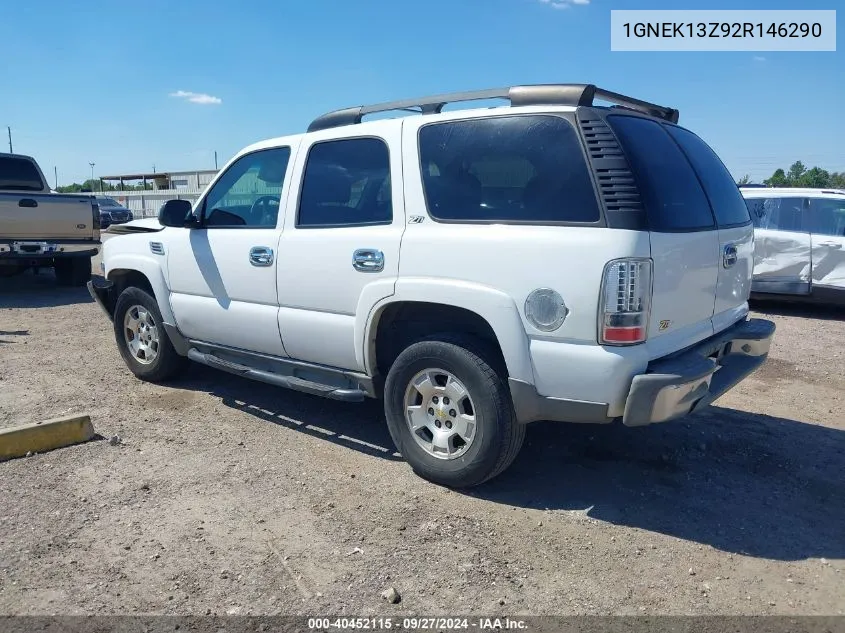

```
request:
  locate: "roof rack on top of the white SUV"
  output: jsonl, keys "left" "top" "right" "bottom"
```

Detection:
{"left": 308, "top": 84, "right": 679, "bottom": 132}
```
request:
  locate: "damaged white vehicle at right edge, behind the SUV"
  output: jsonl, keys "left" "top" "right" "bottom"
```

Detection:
{"left": 741, "top": 187, "right": 845, "bottom": 305}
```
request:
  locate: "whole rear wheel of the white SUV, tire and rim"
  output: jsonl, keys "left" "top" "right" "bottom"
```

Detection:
{"left": 385, "top": 335, "right": 525, "bottom": 488}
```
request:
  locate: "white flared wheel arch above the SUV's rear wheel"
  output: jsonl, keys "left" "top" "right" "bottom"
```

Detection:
{"left": 355, "top": 278, "right": 534, "bottom": 384}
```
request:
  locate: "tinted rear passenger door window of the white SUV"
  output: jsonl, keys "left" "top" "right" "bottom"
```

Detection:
{"left": 297, "top": 138, "right": 393, "bottom": 227}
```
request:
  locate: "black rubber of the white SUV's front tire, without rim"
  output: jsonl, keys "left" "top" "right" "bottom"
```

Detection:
{"left": 114, "top": 286, "right": 188, "bottom": 382}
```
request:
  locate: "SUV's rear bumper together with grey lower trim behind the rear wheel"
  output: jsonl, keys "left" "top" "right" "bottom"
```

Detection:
{"left": 509, "top": 319, "right": 775, "bottom": 426}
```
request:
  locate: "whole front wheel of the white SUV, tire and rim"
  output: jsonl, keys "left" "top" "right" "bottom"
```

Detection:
{"left": 114, "top": 286, "right": 188, "bottom": 382}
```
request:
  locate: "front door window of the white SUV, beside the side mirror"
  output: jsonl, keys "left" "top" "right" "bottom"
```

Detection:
{"left": 204, "top": 147, "right": 290, "bottom": 228}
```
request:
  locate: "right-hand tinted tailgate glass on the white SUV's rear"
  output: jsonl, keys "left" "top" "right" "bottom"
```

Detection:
{"left": 665, "top": 125, "right": 749, "bottom": 226}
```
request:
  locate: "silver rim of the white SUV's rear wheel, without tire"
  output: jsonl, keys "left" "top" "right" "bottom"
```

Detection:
{"left": 404, "top": 369, "right": 476, "bottom": 460}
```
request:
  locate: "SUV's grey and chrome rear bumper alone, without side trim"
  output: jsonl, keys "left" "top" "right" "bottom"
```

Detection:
{"left": 622, "top": 319, "right": 775, "bottom": 426}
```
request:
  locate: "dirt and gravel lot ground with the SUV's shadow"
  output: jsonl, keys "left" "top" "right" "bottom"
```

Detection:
{"left": 0, "top": 275, "right": 845, "bottom": 615}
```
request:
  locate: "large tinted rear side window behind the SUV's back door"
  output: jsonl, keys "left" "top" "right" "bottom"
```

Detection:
{"left": 419, "top": 116, "right": 600, "bottom": 223}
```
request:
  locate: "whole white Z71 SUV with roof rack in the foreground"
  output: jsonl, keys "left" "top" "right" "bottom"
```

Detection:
{"left": 89, "top": 85, "right": 775, "bottom": 487}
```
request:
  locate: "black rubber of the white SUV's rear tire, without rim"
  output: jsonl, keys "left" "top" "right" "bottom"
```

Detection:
{"left": 384, "top": 335, "right": 525, "bottom": 488}
